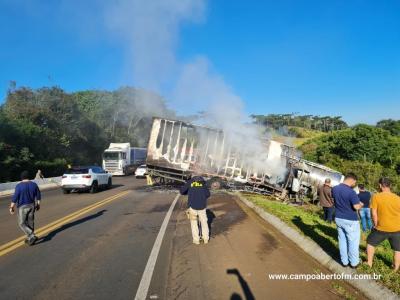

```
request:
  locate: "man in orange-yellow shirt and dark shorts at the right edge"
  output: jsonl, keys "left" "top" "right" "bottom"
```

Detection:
{"left": 367, "top": 178, "right": 400, "bottom": 271}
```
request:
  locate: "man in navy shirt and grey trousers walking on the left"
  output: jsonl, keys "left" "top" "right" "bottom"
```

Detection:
{"left": 10, "top": 171, "right": 41, "bottom": 246}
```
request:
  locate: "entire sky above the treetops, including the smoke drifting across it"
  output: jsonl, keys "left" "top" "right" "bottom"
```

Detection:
{"left": 0, "top": 0, "right": 400, "bottom": 124}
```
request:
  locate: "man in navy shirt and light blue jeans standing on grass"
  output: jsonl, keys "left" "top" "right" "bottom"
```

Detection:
{"left": 332, "top": 173, "right": 363, "bottom": 268}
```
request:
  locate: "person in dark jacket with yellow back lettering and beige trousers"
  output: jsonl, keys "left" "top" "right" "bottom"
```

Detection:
{"left": 181, "top": 175, "right": 210, "bottom": 245}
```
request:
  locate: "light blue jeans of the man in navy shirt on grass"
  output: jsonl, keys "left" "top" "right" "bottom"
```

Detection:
{"left": 335, "top": 218, "right": 360, "bottom": 267}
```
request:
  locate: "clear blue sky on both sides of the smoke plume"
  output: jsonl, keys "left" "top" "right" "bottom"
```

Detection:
{"left": 0, "top": 0, "right": 400, "bottom": 124}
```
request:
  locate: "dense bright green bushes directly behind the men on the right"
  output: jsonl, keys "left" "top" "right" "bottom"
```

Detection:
{"left": 301, "top": 124, "right": 400, "bottom": 191}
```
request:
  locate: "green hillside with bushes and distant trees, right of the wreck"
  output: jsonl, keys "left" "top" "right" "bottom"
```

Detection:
{"left": 253, "top": 114, "right": 400, "bottom": 193}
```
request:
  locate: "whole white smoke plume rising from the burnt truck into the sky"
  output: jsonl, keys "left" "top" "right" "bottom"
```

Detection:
{"left": 104, "top": 0, "right": 285, "bottom": 182}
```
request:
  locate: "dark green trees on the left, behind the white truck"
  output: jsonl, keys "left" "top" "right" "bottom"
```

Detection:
{"left": 0, "top": 85, "right": 174, "bottom": 182}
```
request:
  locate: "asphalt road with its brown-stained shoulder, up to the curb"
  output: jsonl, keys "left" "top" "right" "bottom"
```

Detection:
{"left": 0, "top": 177, "right": 362, "bottom": 299}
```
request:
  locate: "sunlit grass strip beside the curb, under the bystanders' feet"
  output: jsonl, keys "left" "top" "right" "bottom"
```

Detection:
{"left": 242, "top": 193, "right": 400, "bottom": 294}
